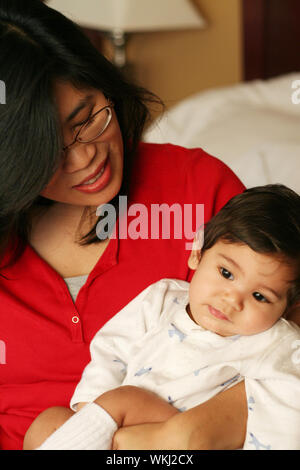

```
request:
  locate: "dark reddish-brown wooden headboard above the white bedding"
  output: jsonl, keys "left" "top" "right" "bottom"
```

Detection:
{"left": 242, "top": 0, "right": 300, "bottom": 80}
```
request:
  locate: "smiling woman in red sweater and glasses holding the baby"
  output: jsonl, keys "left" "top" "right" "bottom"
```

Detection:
{"left": 0, "top": 0, "right": 296, "bottom": 449}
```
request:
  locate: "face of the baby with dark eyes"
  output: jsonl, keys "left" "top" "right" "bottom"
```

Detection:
{"left": 188, "top": 241, "right": 294, "bottom": 336}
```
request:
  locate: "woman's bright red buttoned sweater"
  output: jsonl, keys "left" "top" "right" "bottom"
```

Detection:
{"left": 0, "top": 144, "right": 244, "bottom": 449}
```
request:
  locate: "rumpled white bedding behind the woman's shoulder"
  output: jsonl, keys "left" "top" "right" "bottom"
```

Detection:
{"left": 144, "top": 73, "right": 300, "bottom": 193}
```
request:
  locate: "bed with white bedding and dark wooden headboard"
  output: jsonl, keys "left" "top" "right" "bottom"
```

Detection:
{"left": 143, "top": 0, "right": 300, "bottom": 193}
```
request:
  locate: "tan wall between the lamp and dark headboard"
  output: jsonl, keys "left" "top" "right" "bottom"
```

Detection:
{"left": 106, "top": 0, "right": 242, "bottom": 107}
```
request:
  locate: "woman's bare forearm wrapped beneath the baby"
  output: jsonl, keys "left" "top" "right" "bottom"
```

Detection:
{"left": 113, "top": 382, "right": 248, "bottom": 450}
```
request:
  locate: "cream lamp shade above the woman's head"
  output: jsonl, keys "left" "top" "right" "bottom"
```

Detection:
{"left": 47, "top": 0, "right": 205, "bottom": 32}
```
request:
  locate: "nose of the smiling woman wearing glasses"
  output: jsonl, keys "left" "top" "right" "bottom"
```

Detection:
{"left": 63, "top": 142, "right": 97, "bottom": 173}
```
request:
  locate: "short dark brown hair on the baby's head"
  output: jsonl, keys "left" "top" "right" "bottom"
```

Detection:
{"left": 202, "top": 184, "right": 300, "bottom": 308}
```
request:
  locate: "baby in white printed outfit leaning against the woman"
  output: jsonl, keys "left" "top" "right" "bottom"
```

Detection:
{"left": 24, "top": 185, "right": 300, "bottom": 450}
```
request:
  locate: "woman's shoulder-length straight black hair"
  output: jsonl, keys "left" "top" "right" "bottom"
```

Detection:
{"left": 0, "top": 0, "right": 162, "bottom": 265}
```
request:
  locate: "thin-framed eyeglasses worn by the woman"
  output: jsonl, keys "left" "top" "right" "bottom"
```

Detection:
{"left": 62, "top": 101, "right": 114, "bottom": 152}
